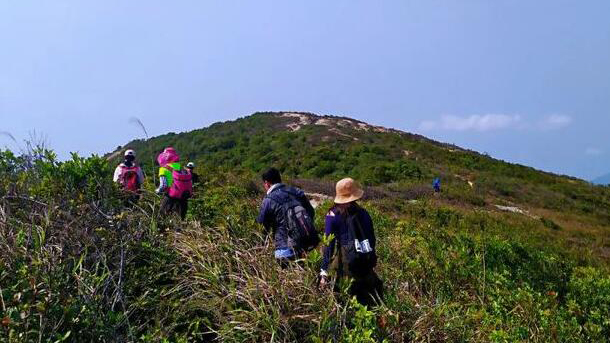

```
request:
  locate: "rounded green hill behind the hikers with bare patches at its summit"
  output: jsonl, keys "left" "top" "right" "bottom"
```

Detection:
{"left": 118, "top": 113, "right": 610, "bottom": 261}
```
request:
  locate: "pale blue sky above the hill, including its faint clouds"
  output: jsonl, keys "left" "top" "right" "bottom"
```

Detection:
{"left": 0, "top": 0, "right": 610, "bottom": 179}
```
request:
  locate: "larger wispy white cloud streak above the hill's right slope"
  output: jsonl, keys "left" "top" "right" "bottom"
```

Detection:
{"left": 419, "top": 114, "right": 521, "bottom": 131}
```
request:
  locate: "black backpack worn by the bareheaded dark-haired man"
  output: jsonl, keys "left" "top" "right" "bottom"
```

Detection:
{"left": 267, "top": 189, "right": 320, "bottom": 252}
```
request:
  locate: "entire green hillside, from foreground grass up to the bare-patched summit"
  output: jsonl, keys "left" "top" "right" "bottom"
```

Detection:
{"left": 0, "top": 114, "right": 610, "bottom": 342}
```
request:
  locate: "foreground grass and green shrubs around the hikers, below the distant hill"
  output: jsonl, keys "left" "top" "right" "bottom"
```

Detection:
{"left": 0, "top": 151, "right": 610, "bottom": 342}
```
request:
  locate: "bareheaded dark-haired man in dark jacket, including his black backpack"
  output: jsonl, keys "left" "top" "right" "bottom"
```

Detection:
{"left": 256, "top": 168, "right": 320, "bottom": 268}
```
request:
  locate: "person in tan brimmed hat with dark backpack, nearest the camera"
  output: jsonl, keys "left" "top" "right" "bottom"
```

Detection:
{"left": 319, "top": 178, "right": 383, "bottom": 305}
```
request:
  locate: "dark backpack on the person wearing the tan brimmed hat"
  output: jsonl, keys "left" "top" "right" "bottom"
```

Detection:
{"left": 345, "top": 211, "right": 377, "bottom": 276}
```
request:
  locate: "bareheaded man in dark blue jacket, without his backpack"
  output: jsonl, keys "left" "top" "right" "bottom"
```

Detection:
{"left": 256, "top": 168, "right": 315, "bottom": 267}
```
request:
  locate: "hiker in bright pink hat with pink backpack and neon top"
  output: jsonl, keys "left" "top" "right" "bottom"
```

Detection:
{"left": 156, "top": 147, "right": 193, "bottom": 220}
